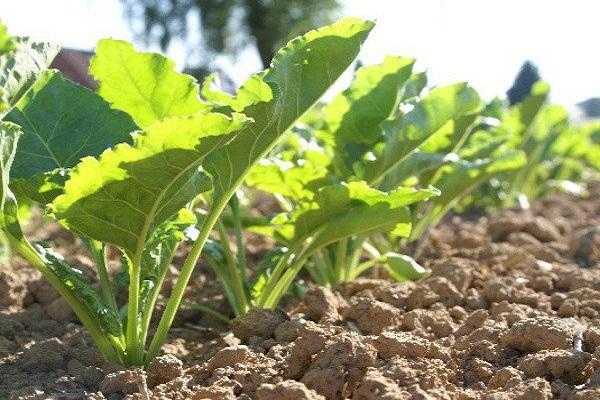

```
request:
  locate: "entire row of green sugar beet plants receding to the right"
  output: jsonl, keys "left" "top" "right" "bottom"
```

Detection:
{"left": 0, "top": 18, "right": 600, "bottom": 366}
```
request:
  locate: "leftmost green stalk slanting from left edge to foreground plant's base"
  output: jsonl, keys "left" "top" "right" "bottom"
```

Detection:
{"left": 11, "top": 238, "right": 123, "bottom": 363}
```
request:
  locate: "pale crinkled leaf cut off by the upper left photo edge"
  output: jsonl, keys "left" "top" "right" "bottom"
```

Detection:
{"left": 0, "top": 38, "right": 59, "bottom": 119}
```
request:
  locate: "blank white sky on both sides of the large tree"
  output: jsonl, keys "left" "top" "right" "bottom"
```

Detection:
{"left": 0, "top": 0, "right": 600, "bottom": 106}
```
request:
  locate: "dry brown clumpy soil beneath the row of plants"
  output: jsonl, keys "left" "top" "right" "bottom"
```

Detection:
{"left": 0, "top": 185, "right": 600, "bottom": 400}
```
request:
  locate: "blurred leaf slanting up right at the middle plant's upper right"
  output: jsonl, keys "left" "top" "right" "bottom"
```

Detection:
{"left": 360, "top": 83, "right": 479, "bottom": 182}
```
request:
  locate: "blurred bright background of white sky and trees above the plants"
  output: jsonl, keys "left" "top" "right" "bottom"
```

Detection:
{"left": 0, "top": 0, "right": 600, "bottom": 119}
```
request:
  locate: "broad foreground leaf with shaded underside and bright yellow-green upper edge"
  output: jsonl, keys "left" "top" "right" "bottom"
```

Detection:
{"left": 53, "top": 113, "right": 248, "bottom": 255}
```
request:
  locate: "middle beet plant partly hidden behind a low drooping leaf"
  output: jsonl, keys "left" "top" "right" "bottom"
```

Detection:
{"left": 243, "top": 57, "right": 524, "bottom": 286}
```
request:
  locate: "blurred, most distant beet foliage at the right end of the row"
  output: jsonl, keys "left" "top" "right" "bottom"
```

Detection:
{"left": 472, "top": 81, "right": 600, "bottom": 207}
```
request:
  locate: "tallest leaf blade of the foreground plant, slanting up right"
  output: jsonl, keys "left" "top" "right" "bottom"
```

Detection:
{"left": 204, "top": 18, "right": 373, "bottom": 213}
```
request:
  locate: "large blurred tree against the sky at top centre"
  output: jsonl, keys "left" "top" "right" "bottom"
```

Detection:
{"left": 121, "top": 0, "right": 340, "bottom": 74}
